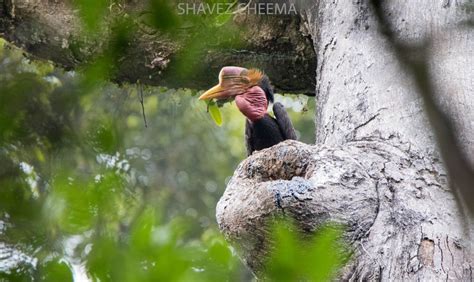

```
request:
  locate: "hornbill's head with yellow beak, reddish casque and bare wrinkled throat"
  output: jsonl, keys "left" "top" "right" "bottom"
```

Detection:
{"left": 199, "top": 67, "right": 273, "bottom": 121}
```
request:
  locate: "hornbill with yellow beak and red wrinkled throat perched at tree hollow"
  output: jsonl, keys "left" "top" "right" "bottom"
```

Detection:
{"left": 199, "top": 66, "right": 296, "bottom": 156}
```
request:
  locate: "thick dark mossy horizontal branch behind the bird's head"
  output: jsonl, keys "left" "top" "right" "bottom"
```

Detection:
{"left": 0, "top": 0, "right": 316, "bottom": 95}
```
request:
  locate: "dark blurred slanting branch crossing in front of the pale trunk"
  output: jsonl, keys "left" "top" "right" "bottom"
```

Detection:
{"left": 371, "top": 0, "right": 474, "bottom": 215}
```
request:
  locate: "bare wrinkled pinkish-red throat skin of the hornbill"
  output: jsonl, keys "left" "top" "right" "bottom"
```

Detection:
{"left": 235, "top": 86, "right": 268, "bottom": 121}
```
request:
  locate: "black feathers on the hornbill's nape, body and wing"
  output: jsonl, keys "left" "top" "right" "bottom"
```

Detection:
{"left": 245, "top": 76, "right": 296, "bottom": 156}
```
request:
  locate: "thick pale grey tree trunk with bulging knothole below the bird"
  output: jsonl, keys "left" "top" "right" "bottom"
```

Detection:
{"left": 216, "top": 0, "right": 474, "bottom": 281}
